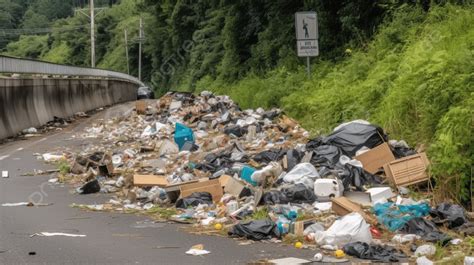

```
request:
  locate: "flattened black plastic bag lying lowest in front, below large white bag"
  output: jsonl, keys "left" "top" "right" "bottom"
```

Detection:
{"left": 342, "top": 242, "right": 407, "bottom": 262}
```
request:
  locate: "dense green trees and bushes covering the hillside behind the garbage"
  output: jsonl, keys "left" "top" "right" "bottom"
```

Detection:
{"left": 0, "top": 0, "right": 474, "bottom": 201}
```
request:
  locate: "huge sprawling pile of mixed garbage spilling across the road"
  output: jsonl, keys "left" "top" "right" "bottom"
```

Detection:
{"left": 43, "top": 91, "right": 473, "bottom": 264}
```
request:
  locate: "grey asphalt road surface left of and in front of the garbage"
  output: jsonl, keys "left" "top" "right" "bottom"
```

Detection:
{"left": 0, "top": 103, "right": 316, "bottom": 264}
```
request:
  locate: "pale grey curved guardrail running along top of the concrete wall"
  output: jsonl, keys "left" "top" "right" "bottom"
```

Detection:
{"left": 0, "top": 55, "right": 144, "bottom": 86}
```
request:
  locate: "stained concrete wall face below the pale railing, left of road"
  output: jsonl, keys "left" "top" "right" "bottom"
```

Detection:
{"left": 0, "top": 78, "right": 137, "bottom": 139}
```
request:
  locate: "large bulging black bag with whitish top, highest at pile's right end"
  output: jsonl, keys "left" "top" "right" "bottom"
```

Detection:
{"left": 322, "top": 122, "right": 387, "bottom": 157}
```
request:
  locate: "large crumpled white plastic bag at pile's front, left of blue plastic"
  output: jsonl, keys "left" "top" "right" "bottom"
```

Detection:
{"left": 315, "top": 212, "right": 372, "bottom": 247}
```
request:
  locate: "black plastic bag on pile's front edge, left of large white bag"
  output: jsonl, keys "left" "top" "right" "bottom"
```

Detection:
{"left": 228, "top": 219, "right": 280, "bottom": 240}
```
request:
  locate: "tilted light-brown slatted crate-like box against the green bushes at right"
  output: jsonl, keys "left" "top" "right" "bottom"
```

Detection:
{"left": 383, "top": 153, "right": 429, "bottom": 187}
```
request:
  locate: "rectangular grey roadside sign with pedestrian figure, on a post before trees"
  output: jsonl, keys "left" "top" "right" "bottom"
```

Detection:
{"left": 295, "top": 11, "right": 319, "bottom": 77}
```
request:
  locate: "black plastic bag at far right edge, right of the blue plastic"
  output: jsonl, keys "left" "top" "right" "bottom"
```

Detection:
{"left": 430, "top": 203, "right": 467, "bottom": 228}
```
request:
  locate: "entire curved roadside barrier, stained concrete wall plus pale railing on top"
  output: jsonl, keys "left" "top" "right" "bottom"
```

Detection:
{"left": 0, "top": 56, "right": 143, "bottom": 139}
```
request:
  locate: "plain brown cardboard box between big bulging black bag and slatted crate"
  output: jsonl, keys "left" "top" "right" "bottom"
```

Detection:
{"left": 354, "top": 143, "right": 395, "bottom": 174}
